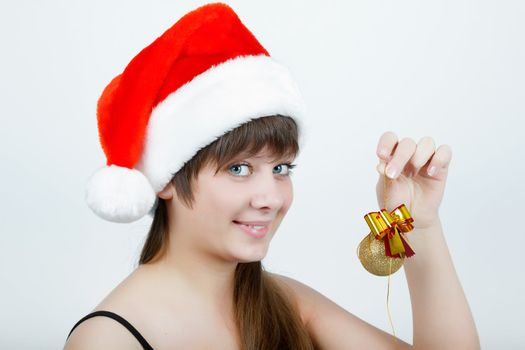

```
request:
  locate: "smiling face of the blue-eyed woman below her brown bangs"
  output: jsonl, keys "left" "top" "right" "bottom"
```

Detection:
{"left": 168, "top": 150, "right": 293, "bottom": 262}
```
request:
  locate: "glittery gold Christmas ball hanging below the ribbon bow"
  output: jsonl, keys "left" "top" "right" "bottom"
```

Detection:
{"left": 358, "top": 233, "right": 405, "bottom": 276}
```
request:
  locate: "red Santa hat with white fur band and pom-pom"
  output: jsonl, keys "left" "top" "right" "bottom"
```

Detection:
{"left": 86, "top": 3, "right": 304, "bottom": 222}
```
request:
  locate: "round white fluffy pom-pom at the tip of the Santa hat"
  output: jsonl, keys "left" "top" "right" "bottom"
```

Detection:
{"left": 86, "top": 165, "right": 156, "bottom": 222}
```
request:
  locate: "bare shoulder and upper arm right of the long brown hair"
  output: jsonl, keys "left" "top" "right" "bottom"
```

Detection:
{"left": 271, "top": 274, "right": 412, "bottom": 349}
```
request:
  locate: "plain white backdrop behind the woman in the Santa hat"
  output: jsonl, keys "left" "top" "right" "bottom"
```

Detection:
{"left": 0, "top": 0, "right": 525, "bottom": 349}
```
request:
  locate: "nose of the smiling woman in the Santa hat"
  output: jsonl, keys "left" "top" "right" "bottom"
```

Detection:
{"left": 250, "top": 174, "right": 292, "bottom": 211}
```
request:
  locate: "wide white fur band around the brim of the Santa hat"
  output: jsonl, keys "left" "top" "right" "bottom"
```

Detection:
{"left": 136, "top": 55, "right": 305, "bottom": 193}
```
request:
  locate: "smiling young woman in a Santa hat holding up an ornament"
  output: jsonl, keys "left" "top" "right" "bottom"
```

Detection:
{"left": 65, "top": 4, "right": 479, "bottom": 350}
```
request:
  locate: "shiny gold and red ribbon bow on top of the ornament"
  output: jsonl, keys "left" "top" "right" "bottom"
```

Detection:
{"left": 364, "top": 204, "right": 414, "bottom": 257}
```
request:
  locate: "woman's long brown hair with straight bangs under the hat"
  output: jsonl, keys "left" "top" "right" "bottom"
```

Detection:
{"left": 139, "top": 115, "right": 314, "bottom": 350}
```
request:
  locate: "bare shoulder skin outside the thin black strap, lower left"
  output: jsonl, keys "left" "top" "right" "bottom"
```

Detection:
{"left": 64, "top": 317, "right": 142, "bottom": 350}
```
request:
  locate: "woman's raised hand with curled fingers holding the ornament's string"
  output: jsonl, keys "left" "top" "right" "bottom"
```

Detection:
{"left": 376, "top": 131, "right": 452, "bottom": 229}
